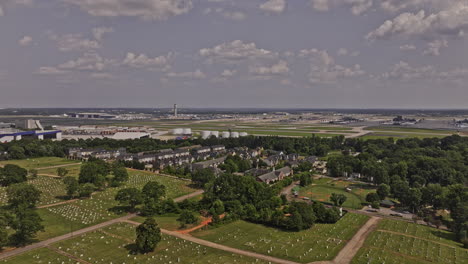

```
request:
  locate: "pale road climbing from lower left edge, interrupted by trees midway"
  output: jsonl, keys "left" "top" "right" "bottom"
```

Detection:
{"left": 0, "top": 190, "right": 203, "bottom": 260}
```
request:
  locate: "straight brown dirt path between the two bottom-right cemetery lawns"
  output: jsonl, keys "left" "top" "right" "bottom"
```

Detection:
{"left": 329, "top": 217, "right": 380, "bottom": 264}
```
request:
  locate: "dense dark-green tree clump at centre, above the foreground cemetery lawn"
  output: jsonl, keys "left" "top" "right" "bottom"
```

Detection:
{"left": 200, "top": 174, "right": 339, "bottom": 231}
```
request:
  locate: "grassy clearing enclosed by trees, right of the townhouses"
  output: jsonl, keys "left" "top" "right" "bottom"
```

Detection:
{"left": 299, "top": 178, "right": 375, "bottom": 209}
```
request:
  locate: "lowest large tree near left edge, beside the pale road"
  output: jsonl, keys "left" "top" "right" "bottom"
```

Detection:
{"left": 10, "top": 205, "right": 44, "bottom": 246}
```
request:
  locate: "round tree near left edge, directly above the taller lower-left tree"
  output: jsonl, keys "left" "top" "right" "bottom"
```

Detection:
{"left": 7, "top": 183, "right": 41, "bottom": 209}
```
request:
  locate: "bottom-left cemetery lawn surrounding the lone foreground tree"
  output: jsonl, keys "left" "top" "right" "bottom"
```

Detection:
{"left": 5, "top": 223, "right": 266, "bottom": 264}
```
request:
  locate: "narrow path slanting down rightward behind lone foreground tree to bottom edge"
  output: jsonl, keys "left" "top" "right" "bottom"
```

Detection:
{"left": 124, "top": 220, "right": 299, "bottom": 264}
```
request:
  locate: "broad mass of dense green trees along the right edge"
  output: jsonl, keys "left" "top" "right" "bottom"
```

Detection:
{"left": 327, "top": 135, "right": 468, "bottom": 244}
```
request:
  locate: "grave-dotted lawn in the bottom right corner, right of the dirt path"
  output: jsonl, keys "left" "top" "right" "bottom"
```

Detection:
{"left": 352, "top": 219, "right": 468, "bottom": 264}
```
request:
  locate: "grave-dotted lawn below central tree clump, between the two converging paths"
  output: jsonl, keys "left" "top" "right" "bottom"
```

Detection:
{"left": 192, "top": 213, "right": 369, "bottom": 263}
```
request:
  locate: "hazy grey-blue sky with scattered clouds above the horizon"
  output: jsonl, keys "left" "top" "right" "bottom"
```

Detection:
{"left": 0, "top": 0, "right": 468, "bottom": 108}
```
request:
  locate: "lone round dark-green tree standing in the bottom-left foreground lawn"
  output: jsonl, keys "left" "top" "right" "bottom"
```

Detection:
{"left": 135, "top": 218, "right": 161, "bottom": 253}
